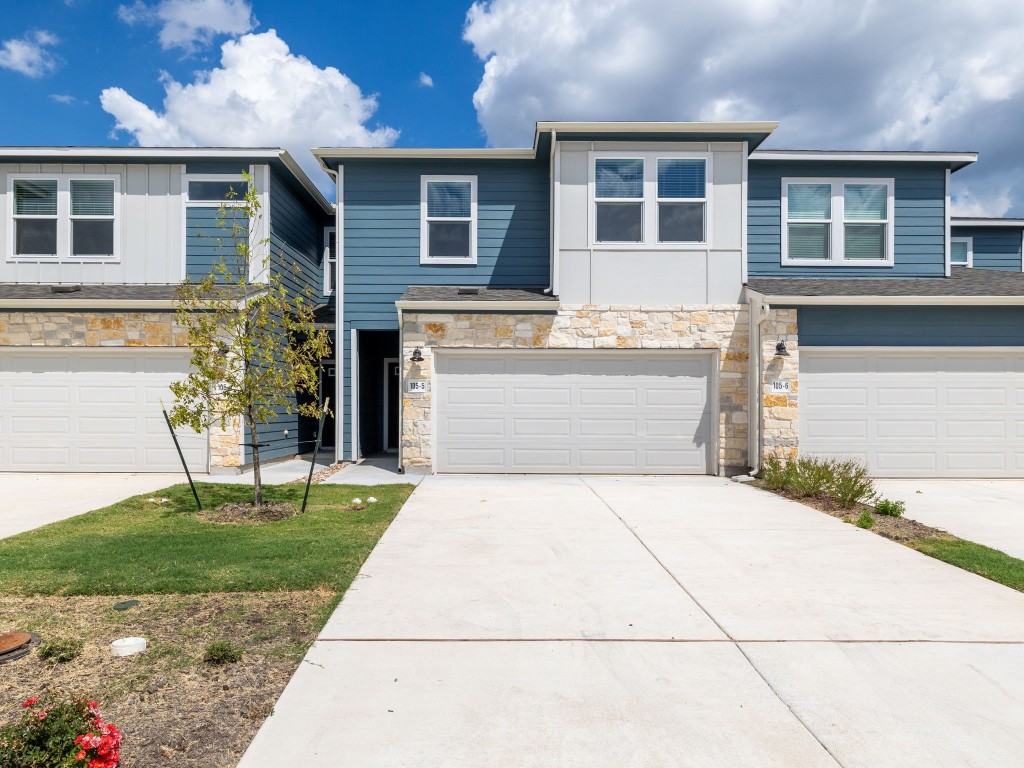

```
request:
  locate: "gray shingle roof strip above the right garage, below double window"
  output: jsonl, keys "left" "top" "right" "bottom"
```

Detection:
{"left": 746, "top": 267, "right": 1024, "bottom": 297}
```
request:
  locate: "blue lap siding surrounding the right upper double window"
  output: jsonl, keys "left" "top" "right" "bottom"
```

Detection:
{"left": 746, "top": 160, "right": 946, "bottom": 278}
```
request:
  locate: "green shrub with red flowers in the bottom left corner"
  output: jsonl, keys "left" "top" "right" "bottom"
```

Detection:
{"left": 0, "top": 694, "right": 121, "bottom": 768}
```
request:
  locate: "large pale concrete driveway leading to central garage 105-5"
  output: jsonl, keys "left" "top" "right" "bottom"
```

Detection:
{"left": 240, "top": 476, "right": 1024, "bottom": 768}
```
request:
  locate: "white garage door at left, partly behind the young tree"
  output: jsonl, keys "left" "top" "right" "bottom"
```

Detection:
{"left": 0, "top": 348, "right": 208, "bottom": 472}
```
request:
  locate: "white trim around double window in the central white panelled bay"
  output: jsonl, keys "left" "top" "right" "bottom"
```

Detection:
{"left": 587, "top": 150, "right": 715, "bottom": 251}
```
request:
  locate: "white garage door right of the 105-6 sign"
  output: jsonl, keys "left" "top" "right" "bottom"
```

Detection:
{"left": 800, "top": 349, "right": 1024, "bottom": 477}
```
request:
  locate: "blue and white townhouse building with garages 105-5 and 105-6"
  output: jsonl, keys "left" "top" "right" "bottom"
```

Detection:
{"left": 314, "top": 123, "right": 1024, "bottom": 477}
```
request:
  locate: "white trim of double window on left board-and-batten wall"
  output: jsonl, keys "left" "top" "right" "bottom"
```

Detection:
{"left": 4, "top": 172, "right": 124, "bottom": 264}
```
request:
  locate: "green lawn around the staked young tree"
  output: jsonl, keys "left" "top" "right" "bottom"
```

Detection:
{"left": 0, "top": 483, "right": 413, "bottom": 595}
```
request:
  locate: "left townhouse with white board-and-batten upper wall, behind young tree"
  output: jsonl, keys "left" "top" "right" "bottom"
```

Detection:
{"left": 0, "top": 147, "right": 334, "bottom": 472}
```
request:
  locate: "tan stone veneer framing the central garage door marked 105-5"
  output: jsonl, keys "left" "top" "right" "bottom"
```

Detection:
{"left": 401, "top": 304, "right": 750, "bottom": 472}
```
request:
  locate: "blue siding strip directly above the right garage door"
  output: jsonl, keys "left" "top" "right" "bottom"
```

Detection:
{"left": 797, "top": 306, "right": 1024, "bottom": 347}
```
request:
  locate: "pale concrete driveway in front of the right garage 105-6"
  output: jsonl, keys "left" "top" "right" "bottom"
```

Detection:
{"left": 874, "top": 480, "right": 1024, "bottom": 559}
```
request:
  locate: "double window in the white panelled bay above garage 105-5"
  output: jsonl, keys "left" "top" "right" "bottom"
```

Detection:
{"left": 592, "top": 153, "right": 710, "bottom": 248}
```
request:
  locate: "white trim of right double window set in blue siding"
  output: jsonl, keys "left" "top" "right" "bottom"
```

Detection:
{"left": 780, "top": 176, "right": 896, "bottom": 267}
